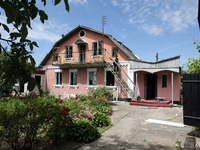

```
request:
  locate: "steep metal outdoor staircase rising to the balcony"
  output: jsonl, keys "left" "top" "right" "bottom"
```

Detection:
{"left": 105, "top": 49, "right": 136, "bottom": 99}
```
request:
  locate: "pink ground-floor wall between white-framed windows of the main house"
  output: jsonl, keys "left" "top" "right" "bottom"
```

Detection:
{"left": 46, "top": 66, "right": 128, "bottom": 98}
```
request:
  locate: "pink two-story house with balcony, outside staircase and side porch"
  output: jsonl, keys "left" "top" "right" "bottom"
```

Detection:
{"left": 36, "top": 25, "right": 180, "bottom": 101}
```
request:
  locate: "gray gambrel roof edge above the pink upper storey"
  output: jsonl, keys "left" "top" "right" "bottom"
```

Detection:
{"left": 39, "top": 25, "right": 141, "bottom": 67}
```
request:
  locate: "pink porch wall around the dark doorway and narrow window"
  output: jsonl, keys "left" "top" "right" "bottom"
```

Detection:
{"left": 134, "top": 71, "right": 180, "bottom": 101}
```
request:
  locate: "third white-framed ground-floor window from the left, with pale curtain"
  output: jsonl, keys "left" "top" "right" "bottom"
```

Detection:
{"left": 87, "top": 68, "right": 97, "bottom": 86}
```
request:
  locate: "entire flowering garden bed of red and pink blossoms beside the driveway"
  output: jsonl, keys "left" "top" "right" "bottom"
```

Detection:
{"left": 0, "top": 87, "right": 112, "bottom": 150}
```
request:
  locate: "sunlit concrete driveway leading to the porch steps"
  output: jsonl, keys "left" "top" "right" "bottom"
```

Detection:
{"left": 79, "top": 103, "right": 200, "bottom": 150}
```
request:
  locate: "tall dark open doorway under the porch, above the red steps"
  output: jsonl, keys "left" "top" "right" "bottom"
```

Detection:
{"left": 145, "top": 74, "right": 157, "bottom": 100}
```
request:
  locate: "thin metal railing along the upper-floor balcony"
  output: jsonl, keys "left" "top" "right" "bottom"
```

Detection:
{"left": 52, "top": 50, "right": 105, "bottom": 65}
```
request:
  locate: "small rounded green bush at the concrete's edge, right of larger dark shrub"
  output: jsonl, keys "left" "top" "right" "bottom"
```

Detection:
{"left": 94, "top": 111, "right": 111, "bottom": 127}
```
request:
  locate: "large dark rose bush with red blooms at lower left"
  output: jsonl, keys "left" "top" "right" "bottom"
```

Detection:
{"left": 0, "top": 95, "right": 71, "bottom": 150}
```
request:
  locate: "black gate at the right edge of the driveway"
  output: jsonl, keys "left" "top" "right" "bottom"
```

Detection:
{"left": 182, "top": 73, "right": 200, "bottom": 127}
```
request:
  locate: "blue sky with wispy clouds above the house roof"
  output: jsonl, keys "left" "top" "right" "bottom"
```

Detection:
{"left": 0, "top": 0, "right": 200, "bottom": 69}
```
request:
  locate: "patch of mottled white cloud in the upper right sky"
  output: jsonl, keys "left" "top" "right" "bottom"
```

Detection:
{"left": 112, "top": 0, "right": 198, "bottom": 35}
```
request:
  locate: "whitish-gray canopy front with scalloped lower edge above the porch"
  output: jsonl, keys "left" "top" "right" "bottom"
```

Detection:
{"left": 130, "top": 56, "right": 180, "bottom": 74}
